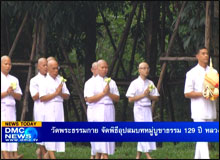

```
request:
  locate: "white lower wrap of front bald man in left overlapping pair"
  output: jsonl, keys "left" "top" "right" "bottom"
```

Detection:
{"left": 45, "top": 102, "right": 65, "bottom": 152}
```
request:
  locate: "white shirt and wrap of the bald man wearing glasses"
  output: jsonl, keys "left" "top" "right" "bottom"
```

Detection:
{"left": 126, "top": 76, "right": 159, "bottom": 152}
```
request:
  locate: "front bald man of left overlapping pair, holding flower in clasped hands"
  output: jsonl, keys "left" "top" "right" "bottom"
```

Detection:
{"left": 39, "top": 60, "right": 70, "bottom": 159}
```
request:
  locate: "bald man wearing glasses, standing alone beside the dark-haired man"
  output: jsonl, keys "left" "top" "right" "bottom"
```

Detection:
{"left": 126, "top": 62, "right": 159, "bottom": 159}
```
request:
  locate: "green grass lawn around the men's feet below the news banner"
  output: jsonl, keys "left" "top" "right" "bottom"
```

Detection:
{"left": 18, "top": 142, "right": 219, "bottom": 159}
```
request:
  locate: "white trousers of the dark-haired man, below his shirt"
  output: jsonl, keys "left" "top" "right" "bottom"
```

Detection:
{"left": 193, "top": 119, "right": 213, "bottom": 159}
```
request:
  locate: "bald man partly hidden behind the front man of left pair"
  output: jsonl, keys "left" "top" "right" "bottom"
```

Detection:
{"left": 29, "top": 58, "right": 47, "bottom": 159}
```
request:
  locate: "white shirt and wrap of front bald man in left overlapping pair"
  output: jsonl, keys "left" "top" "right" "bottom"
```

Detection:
{"left": 39, "top": 74, "right": 70, "bottom": 152}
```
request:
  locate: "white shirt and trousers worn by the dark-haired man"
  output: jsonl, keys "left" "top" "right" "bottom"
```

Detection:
{"left": 184, "top": 64, "right": 217, "bottom": 159}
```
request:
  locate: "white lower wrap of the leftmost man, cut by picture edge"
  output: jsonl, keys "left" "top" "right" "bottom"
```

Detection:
{"left": 1, "top": 103, "right": 18, "bottom": 152}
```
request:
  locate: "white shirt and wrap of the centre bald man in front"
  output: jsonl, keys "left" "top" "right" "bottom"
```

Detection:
{"left": 84, "top": 75, "right": 119, "bottom": 155}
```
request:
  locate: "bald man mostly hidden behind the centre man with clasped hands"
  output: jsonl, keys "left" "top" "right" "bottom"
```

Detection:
{"left": 84, "top": 62, "right": 98, "bottom": 159}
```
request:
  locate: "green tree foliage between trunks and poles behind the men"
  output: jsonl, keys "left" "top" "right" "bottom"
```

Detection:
{"left": 1, "top": 1, "right": 218, "bottom": 120}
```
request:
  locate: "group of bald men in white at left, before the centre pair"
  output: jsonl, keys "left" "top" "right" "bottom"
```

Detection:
{"left": 1, "top": 56, "right": 70, "bottom": 159}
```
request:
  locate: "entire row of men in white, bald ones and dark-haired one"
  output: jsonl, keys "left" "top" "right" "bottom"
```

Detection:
{"left": 1, "top": 47, "right": 216, "bottom": 159}
